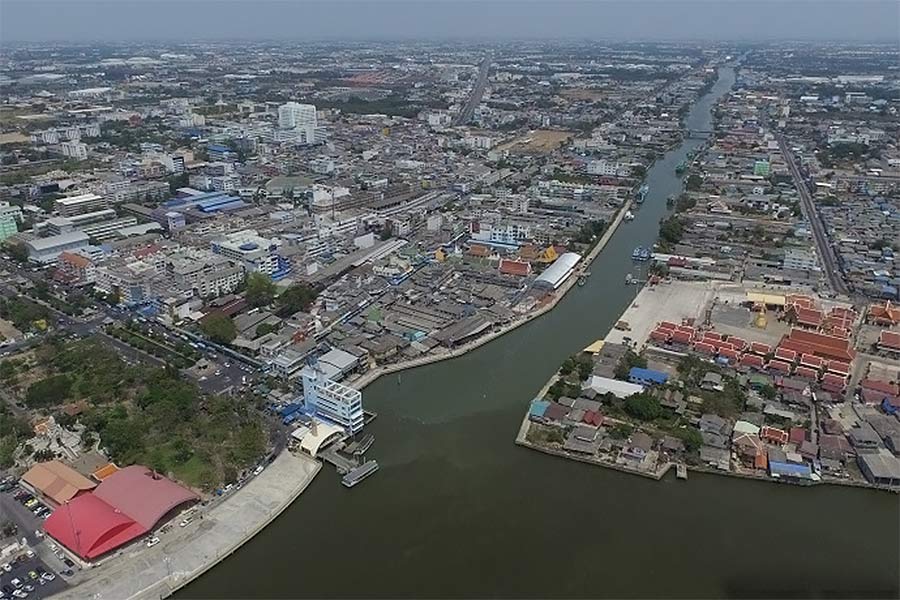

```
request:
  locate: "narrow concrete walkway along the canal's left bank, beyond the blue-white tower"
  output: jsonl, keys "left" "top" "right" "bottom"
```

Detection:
{"left": 347, "top": 191, "right": 633, "bottom": 390}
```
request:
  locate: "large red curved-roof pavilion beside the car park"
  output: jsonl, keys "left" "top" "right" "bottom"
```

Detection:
{"left": 44, "top": 465, "right": 197, "bottom": 560}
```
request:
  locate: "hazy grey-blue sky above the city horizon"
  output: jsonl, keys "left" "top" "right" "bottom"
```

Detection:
{"left": 0, "top": 0, "right": 900, "bottom": 43}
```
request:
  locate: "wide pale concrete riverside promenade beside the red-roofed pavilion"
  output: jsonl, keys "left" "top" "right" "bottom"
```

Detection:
{"left": 53, "top": 450, "right": 322, "bottom": 600}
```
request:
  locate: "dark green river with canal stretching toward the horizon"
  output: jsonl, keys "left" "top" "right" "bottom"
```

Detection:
{"left": 185, "top": 68, "right": 900, "bottom": 598}
